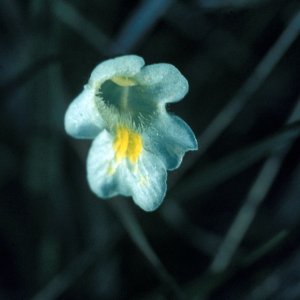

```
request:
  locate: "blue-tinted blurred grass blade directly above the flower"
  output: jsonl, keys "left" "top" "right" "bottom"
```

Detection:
{"left": 111, "top": 0, "right": 173, "bottom": 54}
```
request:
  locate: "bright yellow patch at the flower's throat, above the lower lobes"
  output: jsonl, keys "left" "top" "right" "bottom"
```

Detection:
{"left": 113, "top": 126, "right": 143, "bottom": 163}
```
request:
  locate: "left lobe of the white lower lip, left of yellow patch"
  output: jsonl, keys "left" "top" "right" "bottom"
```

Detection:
{"left": 87, "top": 130, "right": 130, "bottom": 198}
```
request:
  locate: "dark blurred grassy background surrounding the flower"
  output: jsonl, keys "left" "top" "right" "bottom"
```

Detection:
{"left": 0, "top": 0, "right": 300, "bottom": 300}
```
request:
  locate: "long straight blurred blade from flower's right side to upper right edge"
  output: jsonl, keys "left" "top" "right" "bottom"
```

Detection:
{"left": 172, "top": 7, "right": 300, "bottom": 185}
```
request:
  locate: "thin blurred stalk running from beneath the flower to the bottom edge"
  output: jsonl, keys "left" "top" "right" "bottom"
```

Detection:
{"left": 110, "top": 197, "right": 185, "bottom": 299}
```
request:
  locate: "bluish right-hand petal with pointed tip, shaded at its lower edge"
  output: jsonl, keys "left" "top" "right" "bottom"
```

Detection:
{"left": 144, "top": 112, "right": 198, "bottom": 170}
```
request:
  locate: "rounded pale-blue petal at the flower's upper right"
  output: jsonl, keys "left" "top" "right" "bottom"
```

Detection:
{"left": 136, "top": 63, "right": 189, "bottom": 103}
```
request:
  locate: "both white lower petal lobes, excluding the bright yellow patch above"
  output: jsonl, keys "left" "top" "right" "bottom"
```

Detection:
{"left": 87, "top": 130, "right": 167, "bottom": 211}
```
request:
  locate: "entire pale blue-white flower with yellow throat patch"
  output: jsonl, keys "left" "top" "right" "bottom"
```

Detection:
{"left": 65, "top": 55, "right": 197, "bottom": 211}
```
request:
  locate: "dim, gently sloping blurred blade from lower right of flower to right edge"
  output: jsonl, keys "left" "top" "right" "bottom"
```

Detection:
{"left": 175, "top": 121, "right": 300, "bottom": 200}
